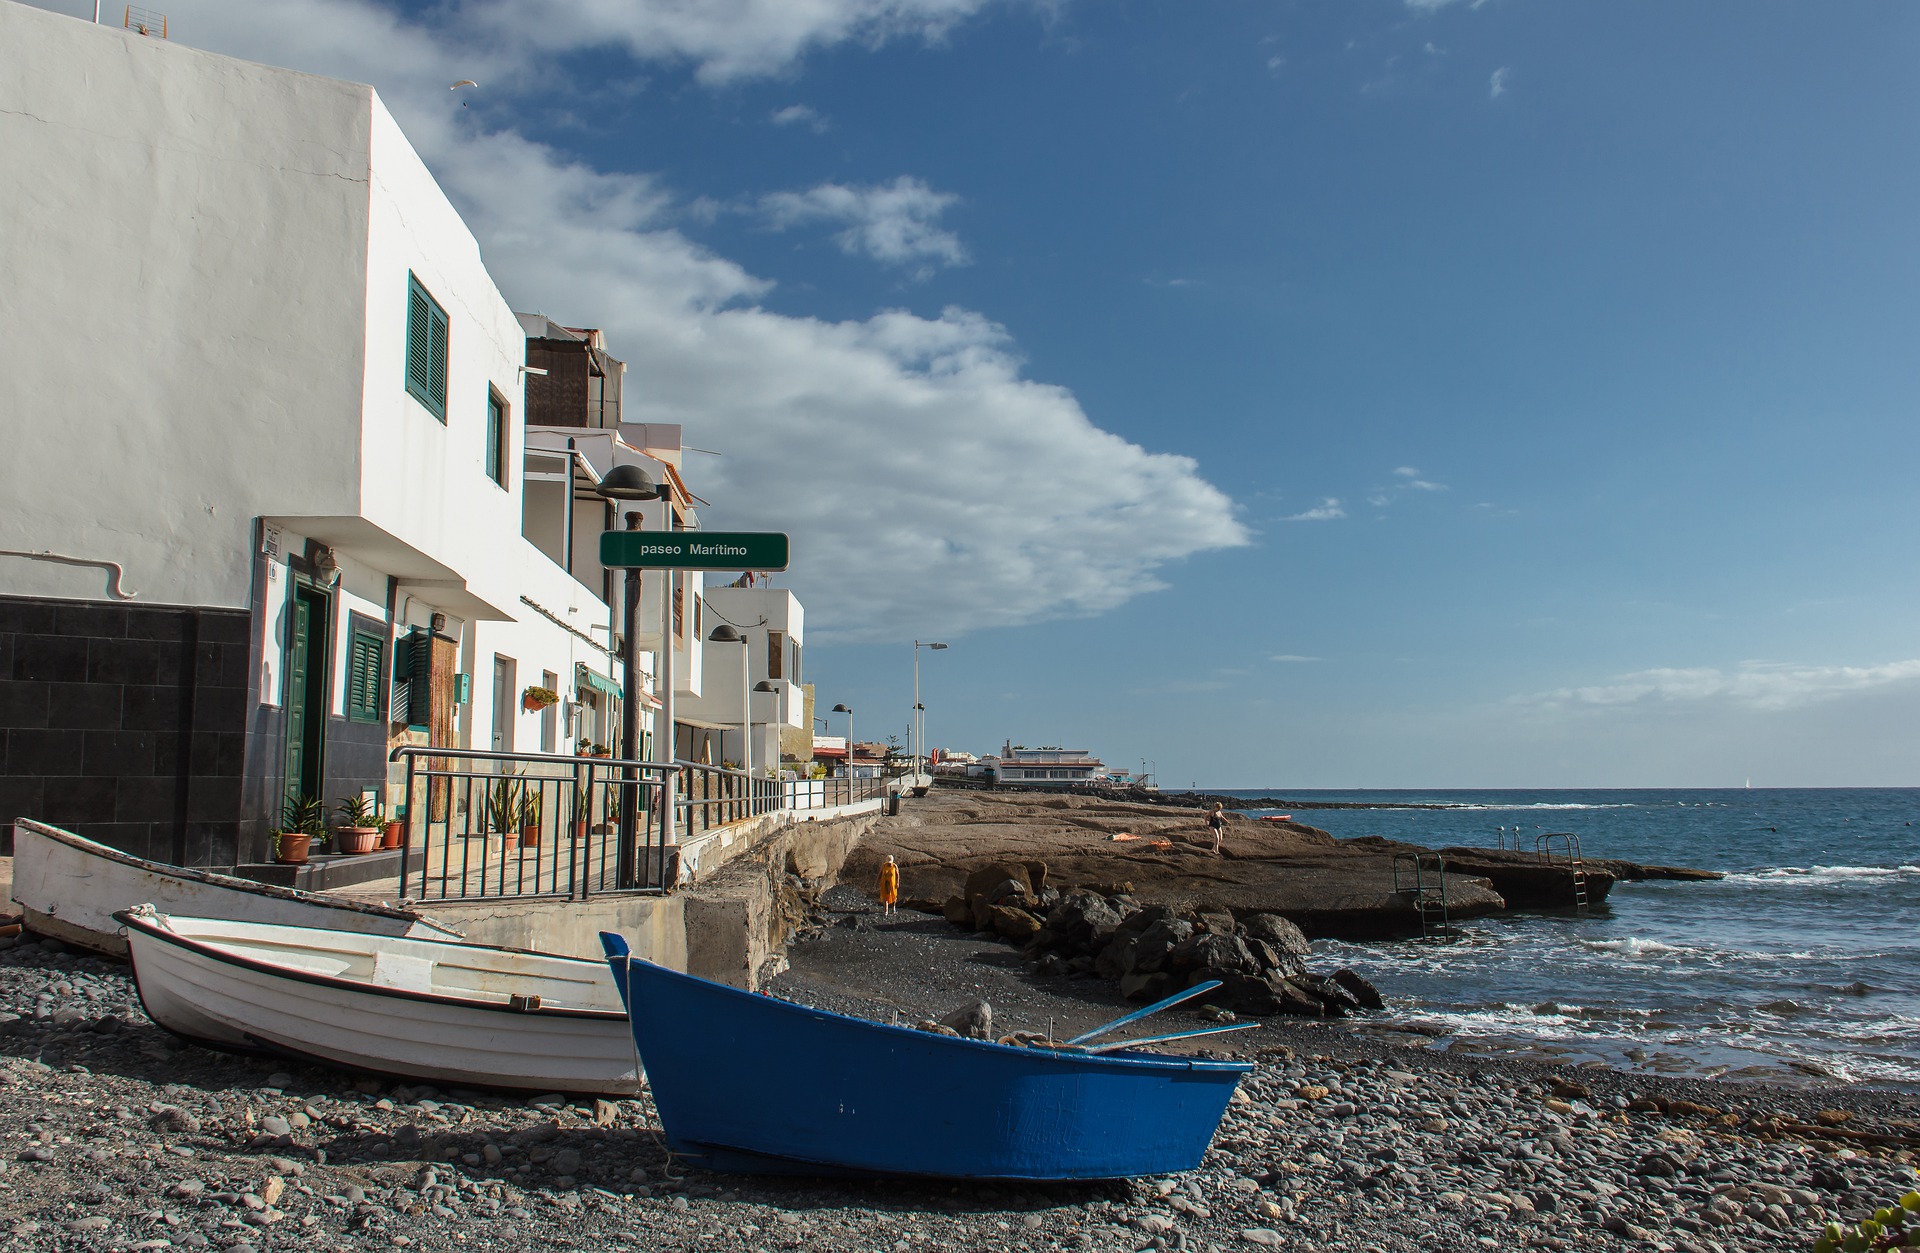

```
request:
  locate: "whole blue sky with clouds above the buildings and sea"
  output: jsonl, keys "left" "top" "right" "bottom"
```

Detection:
{"left": 26, "top": 0, "right": 1920, "bottom": 791}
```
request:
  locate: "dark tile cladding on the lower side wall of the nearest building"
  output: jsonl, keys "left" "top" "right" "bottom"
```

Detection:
{"left": 0, "top": 597, "right": 253, "bottom": 865}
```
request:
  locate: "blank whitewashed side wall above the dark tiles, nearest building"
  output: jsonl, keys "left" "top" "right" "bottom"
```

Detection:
{"left": 0, "top": 4, "right": 372, "bottom": 608}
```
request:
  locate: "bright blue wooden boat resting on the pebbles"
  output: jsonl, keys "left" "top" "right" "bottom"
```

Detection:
{"left": 601, "top": 933, "right": 1252, "bottom": 1180}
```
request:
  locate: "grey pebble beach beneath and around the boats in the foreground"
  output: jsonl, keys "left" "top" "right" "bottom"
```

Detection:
{"left": 0, "top": 888, "right": 1920, "bottom": 1253}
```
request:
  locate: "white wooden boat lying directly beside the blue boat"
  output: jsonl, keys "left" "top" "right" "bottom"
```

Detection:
{"left": 119, "top": 906, "right": 639, "bottom": 1096}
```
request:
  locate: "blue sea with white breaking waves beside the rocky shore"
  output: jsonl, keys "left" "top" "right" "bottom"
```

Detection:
{"left": 1221, "top": 789, "right": 1920, "bottom": 1090}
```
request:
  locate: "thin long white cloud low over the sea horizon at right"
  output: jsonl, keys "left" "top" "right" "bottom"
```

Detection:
{"left": 1517, "top": 660, "right": 1920, "bottom": 710}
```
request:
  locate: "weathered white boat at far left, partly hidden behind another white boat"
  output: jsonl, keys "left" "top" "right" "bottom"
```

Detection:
{"left": 13, "top": 817, "right": 459, "bottom": 957}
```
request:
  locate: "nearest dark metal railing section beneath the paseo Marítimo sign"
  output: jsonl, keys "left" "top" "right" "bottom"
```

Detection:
{"left": 388, "top": 746, "right": 680, "bottom": 900}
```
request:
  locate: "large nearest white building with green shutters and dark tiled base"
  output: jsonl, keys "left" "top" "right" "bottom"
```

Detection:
{"left": 0, "top": 2, "right": 652, "bottom": 865}
